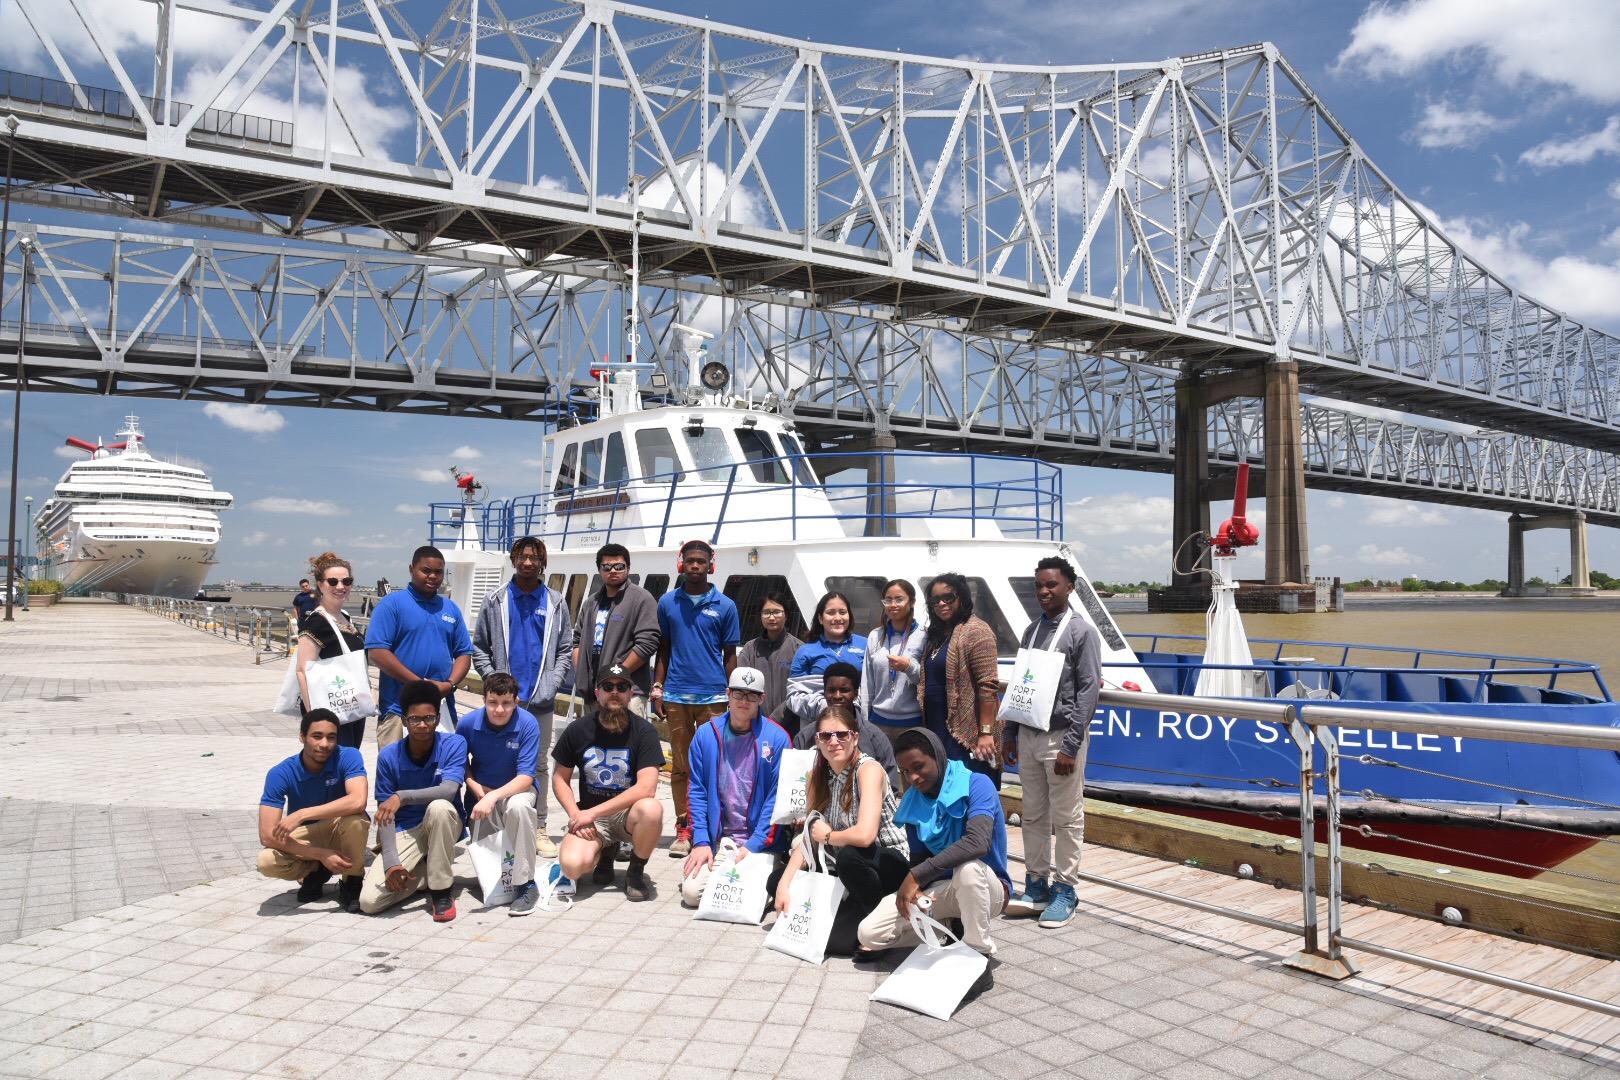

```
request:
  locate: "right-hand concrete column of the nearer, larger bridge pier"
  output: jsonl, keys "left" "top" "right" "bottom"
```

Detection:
{"left": 1264, "top": 359, "right": 1311, "bottom": 585}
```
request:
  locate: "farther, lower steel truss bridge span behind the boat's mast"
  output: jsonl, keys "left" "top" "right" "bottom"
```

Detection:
{"left": 0, "top": 225, "right": 1620, "bottom": 525}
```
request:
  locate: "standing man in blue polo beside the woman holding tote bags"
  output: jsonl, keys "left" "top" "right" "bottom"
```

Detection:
{"left": 366, "top": 544, "right": 473, "bottom": 750}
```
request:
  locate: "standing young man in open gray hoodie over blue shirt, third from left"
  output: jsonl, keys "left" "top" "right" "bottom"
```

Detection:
{"left": 473, "top": 536, "right": 573, "bottom": 858}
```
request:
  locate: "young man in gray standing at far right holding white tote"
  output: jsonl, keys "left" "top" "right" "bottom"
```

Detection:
{"left": 1001, "top": 555, "right": 1102, "bottom": 929}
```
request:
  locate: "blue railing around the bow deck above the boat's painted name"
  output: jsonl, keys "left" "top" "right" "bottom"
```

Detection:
{"left": 1124, "top": 631, "right": 1612, "bottom": 703}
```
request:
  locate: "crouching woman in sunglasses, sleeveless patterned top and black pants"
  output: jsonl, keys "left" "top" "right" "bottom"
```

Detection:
{"left": 776, "top": 704, "right": 910, "bottom": 957}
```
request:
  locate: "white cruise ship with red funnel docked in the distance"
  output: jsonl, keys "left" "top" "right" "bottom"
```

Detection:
{"left": 39, "top": 416, "right": 232, "bottom": 599}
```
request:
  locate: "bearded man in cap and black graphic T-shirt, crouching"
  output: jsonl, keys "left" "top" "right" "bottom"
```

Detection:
{"left": 551, "top": 664, "right": 664, "bottom": 900}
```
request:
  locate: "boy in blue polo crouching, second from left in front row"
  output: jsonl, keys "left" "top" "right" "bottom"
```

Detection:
{"left": 360, "top": 678, "right": 467, "bottom": 923}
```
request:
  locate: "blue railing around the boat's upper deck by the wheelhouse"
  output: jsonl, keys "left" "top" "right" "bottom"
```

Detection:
{"left": 429, "top": 450, "right": 1063, "bottom": 552}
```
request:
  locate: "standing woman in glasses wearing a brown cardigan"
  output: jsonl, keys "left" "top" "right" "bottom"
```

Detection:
{"left": 917, "top": 573, "right": 1001, "bottom": 789}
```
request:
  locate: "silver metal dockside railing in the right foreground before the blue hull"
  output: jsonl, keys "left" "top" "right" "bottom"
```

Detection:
{"left": 1079, "top": 688, "right": 1620, "bottom": 1017}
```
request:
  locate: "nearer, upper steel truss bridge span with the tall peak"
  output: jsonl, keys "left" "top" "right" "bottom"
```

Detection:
{"left": 0, "top": 0, "right": 1620, "bottom": 449}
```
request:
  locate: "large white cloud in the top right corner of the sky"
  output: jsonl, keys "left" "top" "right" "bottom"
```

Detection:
{"left": 1337, "top": 0, "right": 1620, "bottom": 102}
